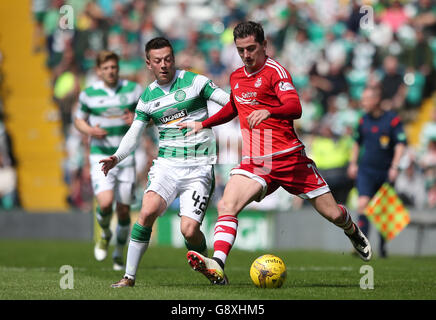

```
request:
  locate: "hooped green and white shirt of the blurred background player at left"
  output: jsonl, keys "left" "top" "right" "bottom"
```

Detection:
{"left": 76, "top": 80, "right": 143, "bottom": 167}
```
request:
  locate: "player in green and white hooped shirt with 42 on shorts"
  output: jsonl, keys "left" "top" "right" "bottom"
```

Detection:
{"left": 100, "top": 37, "right": 229, "bottom": 288}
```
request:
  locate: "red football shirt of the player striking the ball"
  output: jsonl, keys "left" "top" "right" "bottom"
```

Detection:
{"left": 230, "top": 57, "right": 304, "bottom": 158}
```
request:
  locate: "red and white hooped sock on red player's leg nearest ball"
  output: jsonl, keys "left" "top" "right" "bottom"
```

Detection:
{"left": 213, "top": 215, "right": 238, "bottom": 263}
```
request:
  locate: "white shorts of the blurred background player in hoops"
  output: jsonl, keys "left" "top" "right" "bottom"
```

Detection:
{"left": 90, "top": 154, "right": 136, "bottom": 205}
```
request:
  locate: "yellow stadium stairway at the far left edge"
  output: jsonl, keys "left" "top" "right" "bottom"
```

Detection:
{"left": 0, "top": 1, "right": 68, "bottom": 212}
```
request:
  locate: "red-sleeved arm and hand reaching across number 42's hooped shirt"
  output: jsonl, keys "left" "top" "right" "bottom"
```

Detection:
{"left": 178, "top": 95, "right": 238, "bottom": 136}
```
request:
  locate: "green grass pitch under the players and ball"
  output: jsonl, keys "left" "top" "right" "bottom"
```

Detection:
{"left": 0, "top": 240, "right": 436, "bottom": 300}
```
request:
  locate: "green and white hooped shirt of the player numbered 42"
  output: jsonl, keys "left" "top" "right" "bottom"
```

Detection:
{"left": 115, "top": 70, "right": 229, "bottom": 166}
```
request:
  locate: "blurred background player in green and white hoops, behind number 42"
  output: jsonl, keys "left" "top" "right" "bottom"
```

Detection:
{"left": 74, "top": 51, "right": 143, "bottom": 270}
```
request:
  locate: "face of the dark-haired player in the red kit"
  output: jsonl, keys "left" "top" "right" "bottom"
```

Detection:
{"left": 235, "top": 36, "right": 266, "bottom": 73}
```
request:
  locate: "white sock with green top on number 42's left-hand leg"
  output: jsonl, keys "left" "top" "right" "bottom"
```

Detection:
{"left": 125, "top": 222, "right": 152, "bottom": 279}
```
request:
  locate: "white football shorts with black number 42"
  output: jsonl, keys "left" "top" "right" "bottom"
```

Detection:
{"left": 144, "top": 158, "right": 215, "bottom": 224}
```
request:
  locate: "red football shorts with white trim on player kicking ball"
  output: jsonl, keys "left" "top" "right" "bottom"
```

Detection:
{"left": 230, "top": 149, "right": 330, "bottom": 201}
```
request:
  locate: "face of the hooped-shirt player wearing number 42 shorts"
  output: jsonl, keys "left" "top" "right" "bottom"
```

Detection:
{"left": 146, "top": 47, "right": 176, "bottom": 85}
